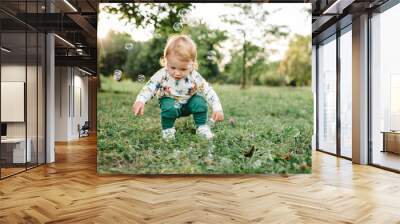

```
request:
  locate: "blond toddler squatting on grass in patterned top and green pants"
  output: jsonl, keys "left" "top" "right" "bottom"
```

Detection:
{"left": 132, "top": 35, "right": 224, "bottom": 140}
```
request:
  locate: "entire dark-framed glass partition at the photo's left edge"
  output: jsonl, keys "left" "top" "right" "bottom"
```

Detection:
{"left": 0, "top": 1, "right": 46, "bottom": 178}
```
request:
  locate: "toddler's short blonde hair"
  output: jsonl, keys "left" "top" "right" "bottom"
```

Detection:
{"left": 160, "top": 34, "right": 198, "bottom": 70}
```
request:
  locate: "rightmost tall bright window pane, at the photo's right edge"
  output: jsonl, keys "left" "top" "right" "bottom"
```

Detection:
{"left": 371, "top": 4, "right": 400, "bottom": 171}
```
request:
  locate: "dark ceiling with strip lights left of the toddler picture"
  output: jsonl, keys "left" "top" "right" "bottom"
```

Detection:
{"left": 0, "top": 0, "right": 98, "bottom": 74}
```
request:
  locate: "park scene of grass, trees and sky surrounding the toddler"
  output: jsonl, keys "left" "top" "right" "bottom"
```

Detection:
{"left": 98, "top": 3, "right": 313, "bottom": 174}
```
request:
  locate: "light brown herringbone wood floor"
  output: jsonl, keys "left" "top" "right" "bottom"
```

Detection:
{"left": 0, "top": 137, "right": 400, "bottom": 224}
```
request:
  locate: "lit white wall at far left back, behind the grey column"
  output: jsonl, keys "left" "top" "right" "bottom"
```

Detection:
{"left": 55, "top": 67, "right": 88, "bottom": 141}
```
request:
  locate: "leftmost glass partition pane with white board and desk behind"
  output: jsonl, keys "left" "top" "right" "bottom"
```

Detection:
{"left": 0, "top": 32, "right": 27, "bottom": 177}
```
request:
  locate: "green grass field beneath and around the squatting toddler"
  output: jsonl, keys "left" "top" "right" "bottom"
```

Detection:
{"left": 97, "top": 77, "right": 313, "bottom": 174}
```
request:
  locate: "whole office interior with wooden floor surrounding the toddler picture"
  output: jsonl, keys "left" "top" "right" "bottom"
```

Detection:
{"left": 0, "top": 0, "right": 400, "bottom": 224}
